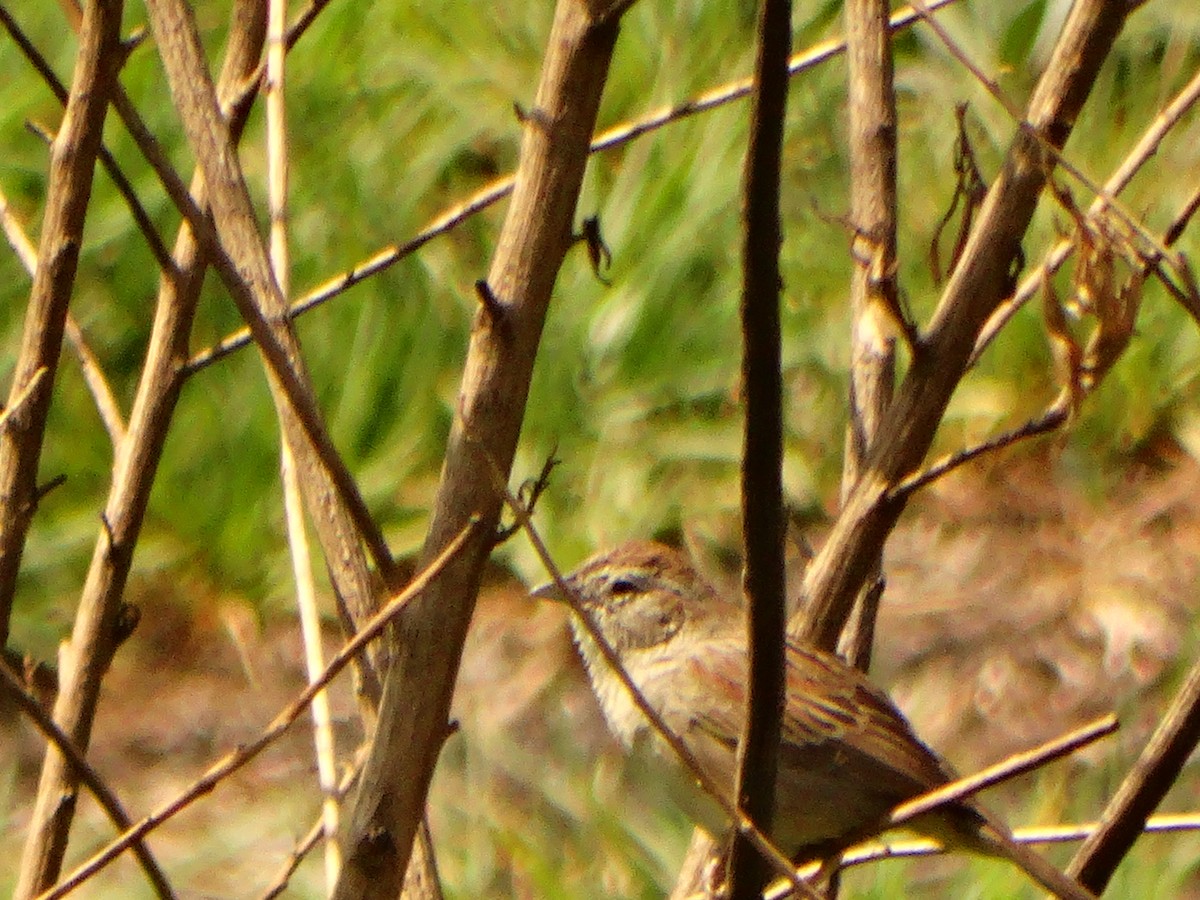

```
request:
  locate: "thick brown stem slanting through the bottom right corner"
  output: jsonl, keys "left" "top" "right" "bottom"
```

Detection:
{"left": 1067, "top": 664, "right": 1200, "bottom": 894}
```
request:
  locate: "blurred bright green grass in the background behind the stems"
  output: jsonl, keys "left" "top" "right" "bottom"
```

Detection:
{"left": 0, "top": 0, "right": 1200, "bottom": 896}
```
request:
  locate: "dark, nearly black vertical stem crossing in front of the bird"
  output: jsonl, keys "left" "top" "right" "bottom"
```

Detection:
{"left": 728, "top": 0, "right": 792, "bottom": 900}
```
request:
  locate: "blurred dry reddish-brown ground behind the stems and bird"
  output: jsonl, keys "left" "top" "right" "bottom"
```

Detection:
{"left": 0, "top": 455, "right": 1200, "bottom": 896}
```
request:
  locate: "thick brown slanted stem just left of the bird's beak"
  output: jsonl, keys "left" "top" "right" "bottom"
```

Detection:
{"left": 334, "top": 0, "right": 662, "bottom": 900}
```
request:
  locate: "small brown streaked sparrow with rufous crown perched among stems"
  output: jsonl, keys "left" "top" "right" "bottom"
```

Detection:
{"left": 533, "top": 542, "right": 1092, "bottom": 900}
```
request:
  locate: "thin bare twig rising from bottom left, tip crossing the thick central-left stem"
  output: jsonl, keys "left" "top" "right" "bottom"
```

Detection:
{"left": 38, "top": 520, "right": 479, "bottom": 900}
